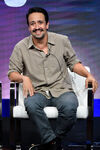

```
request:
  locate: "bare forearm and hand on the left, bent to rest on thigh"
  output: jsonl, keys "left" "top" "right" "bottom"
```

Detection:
{"left": 8, "top": 72, "right": 35, "bottom": 97}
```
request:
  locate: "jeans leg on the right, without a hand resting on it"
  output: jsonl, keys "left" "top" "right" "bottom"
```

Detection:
{"left": 52, "top": 92, "right": 78, "bottom": 138}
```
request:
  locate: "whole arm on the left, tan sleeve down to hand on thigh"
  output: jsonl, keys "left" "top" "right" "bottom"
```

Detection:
{"left": 8, "top": 43, "right": 34, "bottom": 97}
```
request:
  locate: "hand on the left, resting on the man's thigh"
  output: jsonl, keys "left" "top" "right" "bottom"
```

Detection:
{"left": 22, "top": 76, "right": 35, "bottom": 98}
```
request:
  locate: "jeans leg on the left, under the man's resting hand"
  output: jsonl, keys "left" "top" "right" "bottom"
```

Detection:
{"left": 24, "top": 93, "right": 56, "bottom": 144}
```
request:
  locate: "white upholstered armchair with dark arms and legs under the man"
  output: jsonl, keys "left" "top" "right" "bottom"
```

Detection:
{"left": 10, "top": 67, "right": 93, "bottom": 150}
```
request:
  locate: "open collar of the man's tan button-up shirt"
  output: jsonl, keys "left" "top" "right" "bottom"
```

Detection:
{"left": 28, "top": 32, "right": 55, "bottom": 49}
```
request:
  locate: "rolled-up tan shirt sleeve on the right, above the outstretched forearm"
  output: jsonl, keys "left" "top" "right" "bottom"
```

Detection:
{"left": 64, "top": 36, "right": 81, "bottom": 71}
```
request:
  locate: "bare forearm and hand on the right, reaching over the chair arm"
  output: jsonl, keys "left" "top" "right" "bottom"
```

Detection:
{"left": 73, "top": 63, "right": 98, "bottom": 93}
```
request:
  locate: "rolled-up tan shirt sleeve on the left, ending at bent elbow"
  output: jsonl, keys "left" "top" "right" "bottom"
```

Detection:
{"left": 8, "top": 45, "right": 23, "bottom": 76}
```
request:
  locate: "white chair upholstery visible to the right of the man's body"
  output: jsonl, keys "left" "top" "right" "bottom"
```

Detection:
{"left": 69, "top": 66, "right": 90, "bottom": 118}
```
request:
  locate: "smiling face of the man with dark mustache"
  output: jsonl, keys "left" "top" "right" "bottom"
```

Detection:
{"left": 28, "top": 12, "right": 49, "bottom": 39}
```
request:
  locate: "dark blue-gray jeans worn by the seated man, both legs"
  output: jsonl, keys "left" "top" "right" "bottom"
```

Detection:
{"left": 24, "top": 92, "right": 78, "bottom": 144}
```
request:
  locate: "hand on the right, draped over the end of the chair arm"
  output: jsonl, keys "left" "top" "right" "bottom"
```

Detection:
{"left": 85, "top": 74, "right": 98, "bottom": 93}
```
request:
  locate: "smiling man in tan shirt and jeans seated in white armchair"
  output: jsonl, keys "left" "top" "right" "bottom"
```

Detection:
{"left": 8, "top": 7, "right": 97, "bottom": 150}
